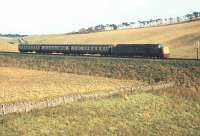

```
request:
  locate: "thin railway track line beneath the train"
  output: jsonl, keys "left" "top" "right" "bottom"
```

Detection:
{"left": 0, "top": 52, "right": 200, "bottom": 61}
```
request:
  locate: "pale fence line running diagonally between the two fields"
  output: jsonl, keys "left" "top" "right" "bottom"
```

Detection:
{"left": 0, "top": 82, "right": 175, "bottom": 116}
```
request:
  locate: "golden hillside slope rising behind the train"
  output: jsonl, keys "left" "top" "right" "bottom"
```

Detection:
{"left": 25, "top": 21, "right": 200, "bottom": 58}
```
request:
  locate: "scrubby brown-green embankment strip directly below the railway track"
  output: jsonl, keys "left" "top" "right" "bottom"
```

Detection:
{"left": 0, "top": 55, "right": 200, "bottom": 86}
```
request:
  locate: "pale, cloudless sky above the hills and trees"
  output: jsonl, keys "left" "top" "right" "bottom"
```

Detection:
{"left": 0, "top": 0, "right": 200, "bottom": 34}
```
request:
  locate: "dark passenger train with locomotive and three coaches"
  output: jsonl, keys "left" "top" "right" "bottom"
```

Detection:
{"left": 19, "top": 44, "right": 170, "bottom": 59}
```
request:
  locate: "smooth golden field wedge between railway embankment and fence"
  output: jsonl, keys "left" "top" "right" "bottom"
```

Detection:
{"left": 0, "top": 67, "right": 140, "bottom": 103}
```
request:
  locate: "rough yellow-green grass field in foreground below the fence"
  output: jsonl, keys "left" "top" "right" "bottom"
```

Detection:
{"left": 0, "top": 90, "right": 200, "bottom": 136}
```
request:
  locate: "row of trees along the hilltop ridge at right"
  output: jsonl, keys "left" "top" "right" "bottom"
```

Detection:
{"left": 73, "top": 11, "right": 200, "bottom": 33}
